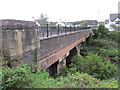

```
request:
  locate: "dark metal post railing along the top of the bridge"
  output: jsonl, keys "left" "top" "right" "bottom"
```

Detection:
{"left": 39, "top": 24, "right": 91, "bottom": 38}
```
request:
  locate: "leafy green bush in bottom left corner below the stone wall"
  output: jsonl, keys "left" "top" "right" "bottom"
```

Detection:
{"left": 1, "top": 65, "right": 54, "bottom": 89}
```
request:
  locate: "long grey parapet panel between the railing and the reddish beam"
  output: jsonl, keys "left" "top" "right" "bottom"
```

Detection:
{"left": 40, "top": 30, "right": 90, "bottom": 59}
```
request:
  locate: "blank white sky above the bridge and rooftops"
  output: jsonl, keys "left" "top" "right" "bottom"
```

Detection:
{"left": 0, "top": 0, "right": 120, "bottom": 21}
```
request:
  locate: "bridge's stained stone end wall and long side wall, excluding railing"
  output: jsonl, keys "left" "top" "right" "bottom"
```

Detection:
{"left": 0, "top": 19, "right": 90, "bottom": 69}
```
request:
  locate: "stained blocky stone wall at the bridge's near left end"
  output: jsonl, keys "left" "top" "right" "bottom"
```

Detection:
{"left": 0, "top": 20, "right": 40, "bottom": 64}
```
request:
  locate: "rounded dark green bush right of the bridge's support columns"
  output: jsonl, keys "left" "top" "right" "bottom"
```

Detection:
{"left": 71, "top": 54, "right": 117, "bottom": 80}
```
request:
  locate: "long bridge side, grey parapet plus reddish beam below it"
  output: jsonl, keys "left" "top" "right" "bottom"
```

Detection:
{"left": 39, "top": 30, "right": 90, "bottom": 69}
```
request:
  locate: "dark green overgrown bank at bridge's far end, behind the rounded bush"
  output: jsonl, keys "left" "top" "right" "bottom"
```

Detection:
{"left": 81, "top": 25, "right": 120, "bottom": 62}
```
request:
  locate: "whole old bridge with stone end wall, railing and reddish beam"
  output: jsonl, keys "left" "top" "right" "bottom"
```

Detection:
{"left": 0, "top": 20, "right": 91, "bottom": 71}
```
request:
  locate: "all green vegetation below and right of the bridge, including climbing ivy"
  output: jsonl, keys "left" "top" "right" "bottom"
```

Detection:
{"left": 0, "top": 25, "right": 120, "bottom": 90}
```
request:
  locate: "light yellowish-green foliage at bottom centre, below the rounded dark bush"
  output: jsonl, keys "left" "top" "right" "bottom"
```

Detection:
{"left": 56, "top": 72, "right": 100, "bottom": 88}
